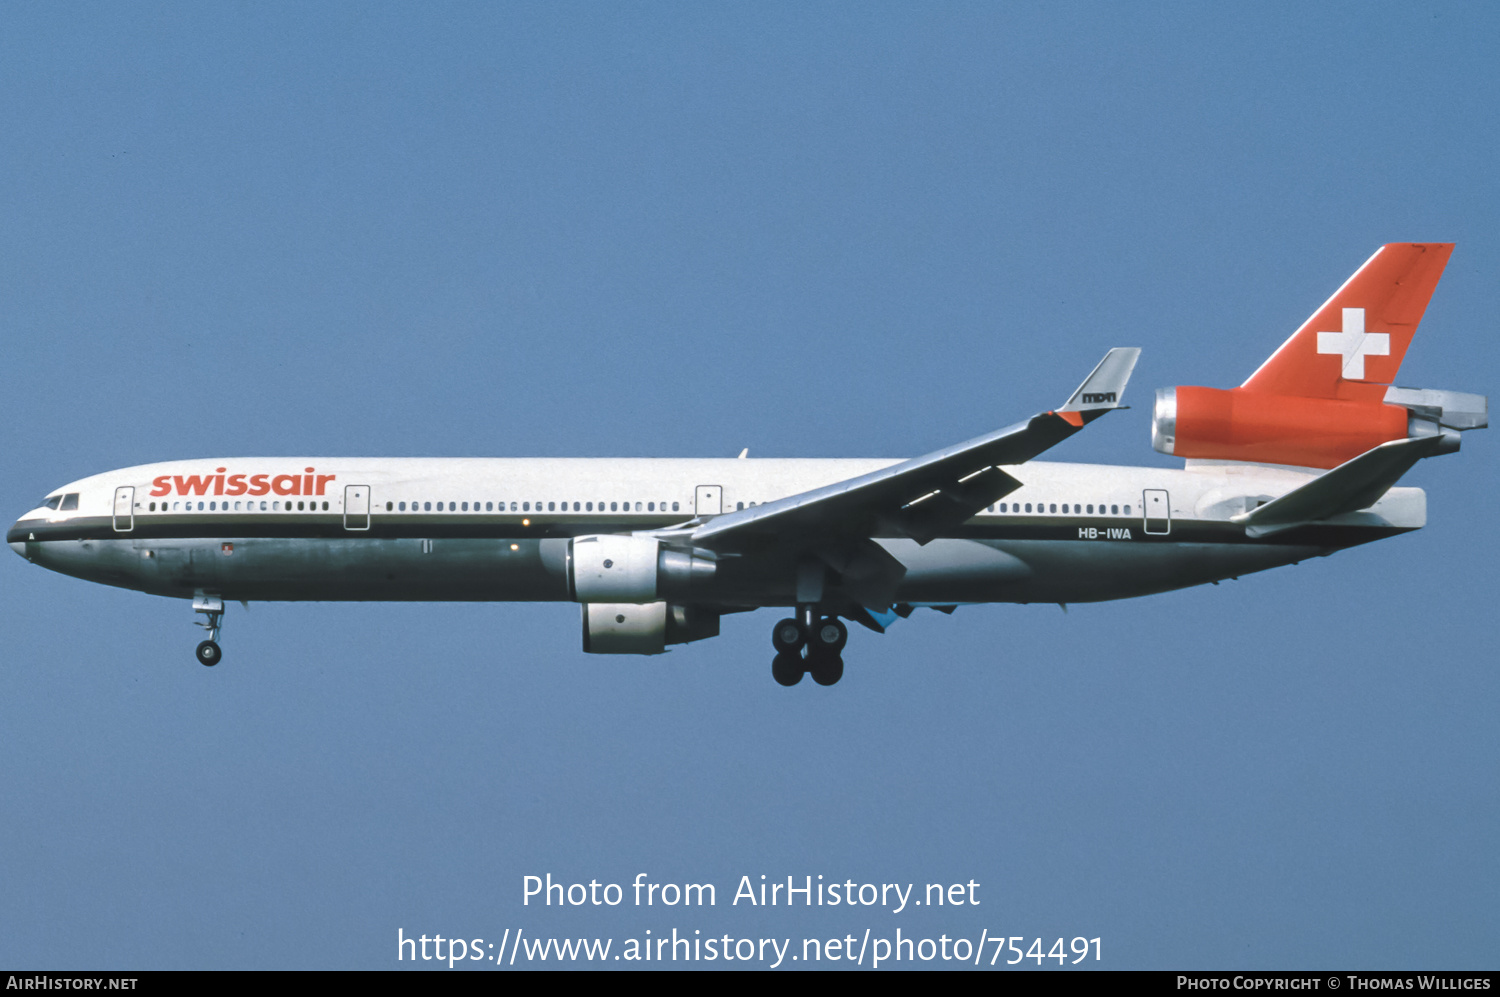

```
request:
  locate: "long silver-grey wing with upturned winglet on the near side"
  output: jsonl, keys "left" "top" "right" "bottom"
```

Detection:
{"left": 674, "top": 348, "right": 1140, "bottom": 559}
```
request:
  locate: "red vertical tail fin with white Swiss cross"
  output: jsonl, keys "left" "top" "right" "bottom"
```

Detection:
{"left": 1241, "top": 243, "right": 1454, "bottom": 402}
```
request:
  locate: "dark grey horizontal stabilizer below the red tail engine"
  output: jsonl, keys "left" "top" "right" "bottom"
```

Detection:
{"left": 1233, "top": 436, "right": 1454, "bottom": 537}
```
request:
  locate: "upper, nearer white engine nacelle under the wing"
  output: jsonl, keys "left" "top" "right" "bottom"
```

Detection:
{"left": 567, "top": 534, "right": 717, "bottom": 604}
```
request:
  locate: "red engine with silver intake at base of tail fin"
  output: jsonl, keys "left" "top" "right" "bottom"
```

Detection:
{"left": 1151, "top": 387, "right": 1490, "bottom": 468}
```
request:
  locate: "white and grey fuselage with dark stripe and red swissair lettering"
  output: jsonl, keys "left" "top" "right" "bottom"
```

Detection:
{"left": 8, "top": 457, "right": 1425, "bottom": 612}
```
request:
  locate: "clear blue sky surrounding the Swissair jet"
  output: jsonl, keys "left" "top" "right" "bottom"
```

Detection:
{"left": 0, "top": 3, "right": 1500, "bottom": 969}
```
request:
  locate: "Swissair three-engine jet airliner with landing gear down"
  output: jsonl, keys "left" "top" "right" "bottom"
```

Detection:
{"left": 6, "top": 243, "right": 1488, "bottom": 685}
